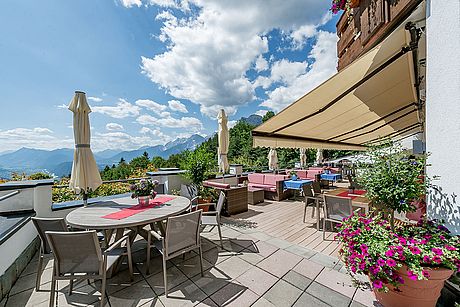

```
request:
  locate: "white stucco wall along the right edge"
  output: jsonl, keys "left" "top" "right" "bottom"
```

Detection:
{"left": 426, "top": 0, "right": 460, "bottom": 233}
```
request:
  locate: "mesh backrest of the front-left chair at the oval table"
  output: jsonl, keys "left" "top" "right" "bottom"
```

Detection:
{"left": 45, "top": 230, "right": 103, "bottom": 275}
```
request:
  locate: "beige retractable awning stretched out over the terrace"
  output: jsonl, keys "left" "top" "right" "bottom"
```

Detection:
{"left": 252, "top": 27, "right": 422, "bottom": 150}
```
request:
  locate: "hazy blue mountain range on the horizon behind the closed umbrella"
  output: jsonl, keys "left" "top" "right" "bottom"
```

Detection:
{"left": 0, "top": 134, "right": 206, "bottom": 178}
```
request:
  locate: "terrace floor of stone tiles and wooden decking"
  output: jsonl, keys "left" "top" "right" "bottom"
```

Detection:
{"left": 2, "top": 195, "right": 375, "bottom": 306}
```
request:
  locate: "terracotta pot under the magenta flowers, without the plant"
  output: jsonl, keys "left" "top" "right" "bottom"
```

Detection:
{"left": 374, "top": 266, "right": 453, "bottom": 307}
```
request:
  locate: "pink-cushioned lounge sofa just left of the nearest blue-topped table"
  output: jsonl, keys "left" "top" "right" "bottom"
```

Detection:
{"left": 248, "top": 173, "right": 292, "bottom": 201}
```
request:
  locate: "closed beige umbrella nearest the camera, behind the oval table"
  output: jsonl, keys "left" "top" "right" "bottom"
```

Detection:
{"left": 69, "top": 91, "right": 102, "bottom": 205}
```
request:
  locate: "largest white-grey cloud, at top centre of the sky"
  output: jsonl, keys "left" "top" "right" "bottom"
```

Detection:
{"left": 142, "top": 0, "right": 335, "bottom": 118}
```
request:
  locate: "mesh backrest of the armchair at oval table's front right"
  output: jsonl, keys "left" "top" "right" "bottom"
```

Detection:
{"left": 164, "top": 210, "right": 202, "bottom": 256}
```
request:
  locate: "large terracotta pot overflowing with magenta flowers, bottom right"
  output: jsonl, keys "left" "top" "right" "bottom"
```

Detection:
{"left": 337, "top": 214, "right": 460, "bottom": 307}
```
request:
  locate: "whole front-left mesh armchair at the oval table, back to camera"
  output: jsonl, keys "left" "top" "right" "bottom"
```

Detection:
{"left": 45, "top": 230, "right": 133, "bottom": 307}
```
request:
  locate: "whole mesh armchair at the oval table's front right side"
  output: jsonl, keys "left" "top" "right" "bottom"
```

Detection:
{"left": 147, "top": 210, "right": 203, "bottom": 297}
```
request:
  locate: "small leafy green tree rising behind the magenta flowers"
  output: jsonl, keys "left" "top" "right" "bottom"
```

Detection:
{"left": 357, "top": 142, "right": 428, "bottom": 228}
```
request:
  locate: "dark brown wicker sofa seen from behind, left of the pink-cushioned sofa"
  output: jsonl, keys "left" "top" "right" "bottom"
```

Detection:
{"left": 203, "top": 180, "right": 248, "bottom": 216}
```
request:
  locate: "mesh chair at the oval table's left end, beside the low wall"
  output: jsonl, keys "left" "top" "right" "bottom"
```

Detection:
{"left": 32, "top": 217, "right": 69, "bottom": 291}
